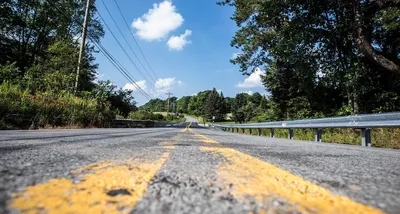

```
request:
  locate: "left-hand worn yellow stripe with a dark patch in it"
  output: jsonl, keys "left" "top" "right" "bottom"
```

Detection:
{"left": 9, "top": 152, "right": 169, "bottom": 213}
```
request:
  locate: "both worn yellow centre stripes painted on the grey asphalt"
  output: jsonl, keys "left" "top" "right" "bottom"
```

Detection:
{"left": 10, "top": 123, "right": 382, "bottom": 214}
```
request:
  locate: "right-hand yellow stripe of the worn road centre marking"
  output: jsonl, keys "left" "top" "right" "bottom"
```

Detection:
{"left": 191, "top": 131, "right": 382, "bottom": 214}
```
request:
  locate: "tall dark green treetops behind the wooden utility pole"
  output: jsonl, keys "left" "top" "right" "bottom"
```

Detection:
{"left": 0, "top": 0, "right": 104, "bottom": 85}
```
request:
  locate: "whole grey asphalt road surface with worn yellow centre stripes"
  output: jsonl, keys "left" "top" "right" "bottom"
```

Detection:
{"left": 0, "top": 120, "right": 400, "bottom": 214}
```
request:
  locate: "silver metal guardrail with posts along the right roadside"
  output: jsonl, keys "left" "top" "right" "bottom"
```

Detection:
{"left": 214, "top": 112, "right": 400, "bottom": 146}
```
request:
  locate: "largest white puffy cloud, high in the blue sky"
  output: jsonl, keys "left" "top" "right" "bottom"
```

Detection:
{"left": 132, "top": 0, "right": 184, "bottom": 41}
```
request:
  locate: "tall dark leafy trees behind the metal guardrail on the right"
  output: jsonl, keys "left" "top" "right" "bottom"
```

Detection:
{"left": 219, "top": 0, "right": 400, "bottom": 119}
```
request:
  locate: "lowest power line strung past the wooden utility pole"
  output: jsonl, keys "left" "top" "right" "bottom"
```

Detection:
{"left": 47, "top": 1, "right": 151, "bottom": 100}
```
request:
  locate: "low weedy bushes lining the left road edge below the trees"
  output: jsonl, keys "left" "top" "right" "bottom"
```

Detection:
{"left": 0, "top": 83, "right": 115, "bottom": 128}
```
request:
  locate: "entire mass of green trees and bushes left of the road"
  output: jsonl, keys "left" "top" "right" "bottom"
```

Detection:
{"left": 0, "top": 0, "right": 136, "bottom": 125}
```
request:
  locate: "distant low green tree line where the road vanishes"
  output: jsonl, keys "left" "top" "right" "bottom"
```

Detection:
{"left": 139, "top": 88, "right": 269, "bottom": 123}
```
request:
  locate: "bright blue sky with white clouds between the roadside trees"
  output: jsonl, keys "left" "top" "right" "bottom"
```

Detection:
{"left": 96, "top": 0, "right": 265, "bottom": 105}
